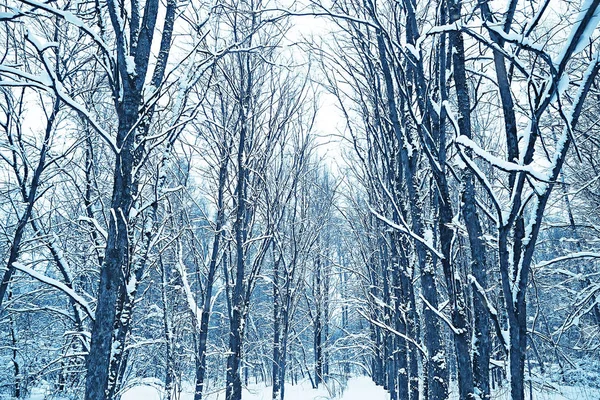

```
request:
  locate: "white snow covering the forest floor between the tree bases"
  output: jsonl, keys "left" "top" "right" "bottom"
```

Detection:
{"left": 117, "top": 377, "right": 600, "bottom": 400}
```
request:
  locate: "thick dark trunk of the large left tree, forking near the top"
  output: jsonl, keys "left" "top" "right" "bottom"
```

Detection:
{"left": 85, "top": 0, "right": 177, "bottom": 400}
